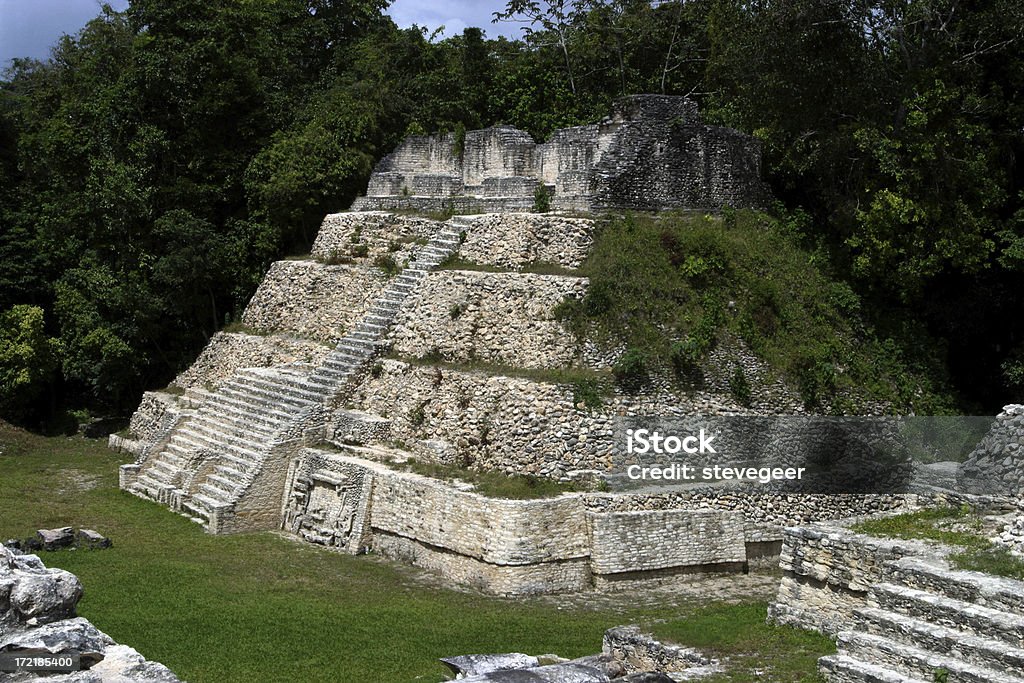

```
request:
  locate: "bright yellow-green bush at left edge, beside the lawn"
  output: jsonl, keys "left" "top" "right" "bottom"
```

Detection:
{"left": 0, "top": 305, "right": 59, "bottom": 420}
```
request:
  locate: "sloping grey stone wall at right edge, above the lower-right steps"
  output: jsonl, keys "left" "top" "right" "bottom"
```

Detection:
{"left": 956, "top": 405, "right": 1024, "bottom": 498}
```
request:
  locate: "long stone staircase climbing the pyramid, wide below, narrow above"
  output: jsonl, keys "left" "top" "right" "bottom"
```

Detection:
{"left": 123, "top": 222, "right": 461, "bottom": 531}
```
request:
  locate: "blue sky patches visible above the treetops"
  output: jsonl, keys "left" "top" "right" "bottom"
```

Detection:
{"left": 0, "top": 0, "right": 520, "bottom": 68}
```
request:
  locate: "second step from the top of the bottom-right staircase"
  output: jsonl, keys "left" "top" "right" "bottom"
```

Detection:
{"left": 867, "top": 584, "right": 1024, "bottom": 647}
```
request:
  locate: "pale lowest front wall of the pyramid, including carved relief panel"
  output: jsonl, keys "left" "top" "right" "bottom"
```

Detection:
{"left": 283, "top": 449, "right": 774, "bottom": 594}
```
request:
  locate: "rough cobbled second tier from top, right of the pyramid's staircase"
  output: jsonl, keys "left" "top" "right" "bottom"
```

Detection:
{"left": 391, "top": 270, "right": 587, "bottom": 368}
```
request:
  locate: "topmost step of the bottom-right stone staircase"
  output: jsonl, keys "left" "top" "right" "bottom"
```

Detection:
{"left": 886, "top": 557, "right": 1024, "bottom": 613}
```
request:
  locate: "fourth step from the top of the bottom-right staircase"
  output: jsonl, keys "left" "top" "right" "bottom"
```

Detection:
{"left": 837, "top": 631, "right": 1021, "bottom": 683}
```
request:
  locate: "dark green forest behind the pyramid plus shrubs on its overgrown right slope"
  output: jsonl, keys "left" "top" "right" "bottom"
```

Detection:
{"left": 0, "top": 0, "right": 1024, "bottom": 419}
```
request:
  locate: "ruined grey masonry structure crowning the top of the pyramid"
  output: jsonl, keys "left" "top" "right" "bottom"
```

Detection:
{"left": 352, "top": 95, "right": 767, "bottom": 211}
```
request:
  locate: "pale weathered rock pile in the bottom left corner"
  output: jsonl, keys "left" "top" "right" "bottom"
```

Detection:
{"left": 0, "top": 547, "right": 178, "bottom": 683}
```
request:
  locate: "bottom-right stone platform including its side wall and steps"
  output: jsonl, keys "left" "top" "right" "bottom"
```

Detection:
{"left": 769, "top": 526, "right": 1024, "bottom": 683}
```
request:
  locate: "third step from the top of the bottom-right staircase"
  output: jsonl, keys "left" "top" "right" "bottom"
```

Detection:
{"left": 855, "top": 607, "right": 1024, "bottom": 676}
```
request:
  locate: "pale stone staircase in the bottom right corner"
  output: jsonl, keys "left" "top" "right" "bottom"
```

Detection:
{"left": 818, "top": 557, "right": 1024, "bottom": 683}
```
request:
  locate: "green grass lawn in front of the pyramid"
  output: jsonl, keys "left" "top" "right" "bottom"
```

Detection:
{"left": 0, "top": 426, "right": 830, "bottom": 683}
